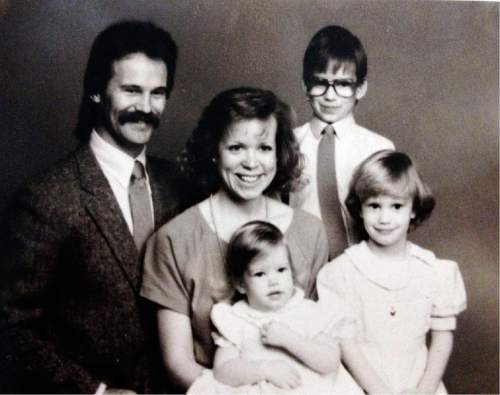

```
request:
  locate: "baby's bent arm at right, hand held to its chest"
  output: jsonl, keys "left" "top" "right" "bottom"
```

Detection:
{"left": 261, "top": 321, "right": 340, "bottom": 374}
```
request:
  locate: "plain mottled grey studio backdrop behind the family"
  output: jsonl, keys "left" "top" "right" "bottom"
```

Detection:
{"left": 0, "top": 0, "right": 499, "bottom": 393}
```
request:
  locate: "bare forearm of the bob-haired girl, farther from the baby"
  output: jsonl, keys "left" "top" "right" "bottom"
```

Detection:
{"left": 417, "top": 330, "right": 453, "bottom": 394}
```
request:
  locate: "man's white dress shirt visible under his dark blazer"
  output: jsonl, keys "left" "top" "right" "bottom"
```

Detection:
{"left": 90, "top": 130, "right": 154, "bottom": 235}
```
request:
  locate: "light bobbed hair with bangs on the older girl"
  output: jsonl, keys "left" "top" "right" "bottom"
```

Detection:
{"left": 345, "top": 150, "right": 435, "bottom": 238}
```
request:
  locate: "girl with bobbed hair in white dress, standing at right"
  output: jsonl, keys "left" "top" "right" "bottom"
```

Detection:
{"left": 317, "top": 150, "right": 465, "bottom": 394}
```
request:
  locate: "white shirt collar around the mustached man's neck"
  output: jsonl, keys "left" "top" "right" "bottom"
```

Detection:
{"left": 89, "top": 130, "right": 147, "bottom": 188}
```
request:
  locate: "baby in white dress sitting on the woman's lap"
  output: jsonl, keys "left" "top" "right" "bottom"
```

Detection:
{"left": 188, "top": 221, "right": 362, "bottom": 394}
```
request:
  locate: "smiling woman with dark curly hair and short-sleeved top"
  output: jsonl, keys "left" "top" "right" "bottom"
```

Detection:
{"left": 141, "top": 87, "right": 328, "bottom": 390}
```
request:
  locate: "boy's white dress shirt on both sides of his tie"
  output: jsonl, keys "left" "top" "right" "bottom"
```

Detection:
{"left": 290, "top": 115, "right": 394, "bottom": 244}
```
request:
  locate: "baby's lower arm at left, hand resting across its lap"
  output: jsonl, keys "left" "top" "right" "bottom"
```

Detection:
{"left": 214, "top": 346, "right": 300, "bottom": 390}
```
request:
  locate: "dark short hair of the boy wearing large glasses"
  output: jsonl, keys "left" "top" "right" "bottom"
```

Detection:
{"left": 302, "top": 25, "right": 368, "bottom": 85}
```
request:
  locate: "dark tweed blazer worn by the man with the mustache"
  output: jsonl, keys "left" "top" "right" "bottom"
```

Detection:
{"left": 0, "top": 145, "right": 188, "bottom": 393}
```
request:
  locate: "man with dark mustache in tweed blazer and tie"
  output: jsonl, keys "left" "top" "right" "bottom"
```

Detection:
{"left": 0, "top": 21, "right": 183, "bottom": 393}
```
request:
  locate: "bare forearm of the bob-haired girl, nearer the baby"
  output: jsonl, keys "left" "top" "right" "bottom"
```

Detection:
{"left": 340, "top": 340, "right": 392, "bottom": 394}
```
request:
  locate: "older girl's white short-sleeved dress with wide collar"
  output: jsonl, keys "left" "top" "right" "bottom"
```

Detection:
{"left": 317, "top": 242, "right": 466, "bottom": 394}
